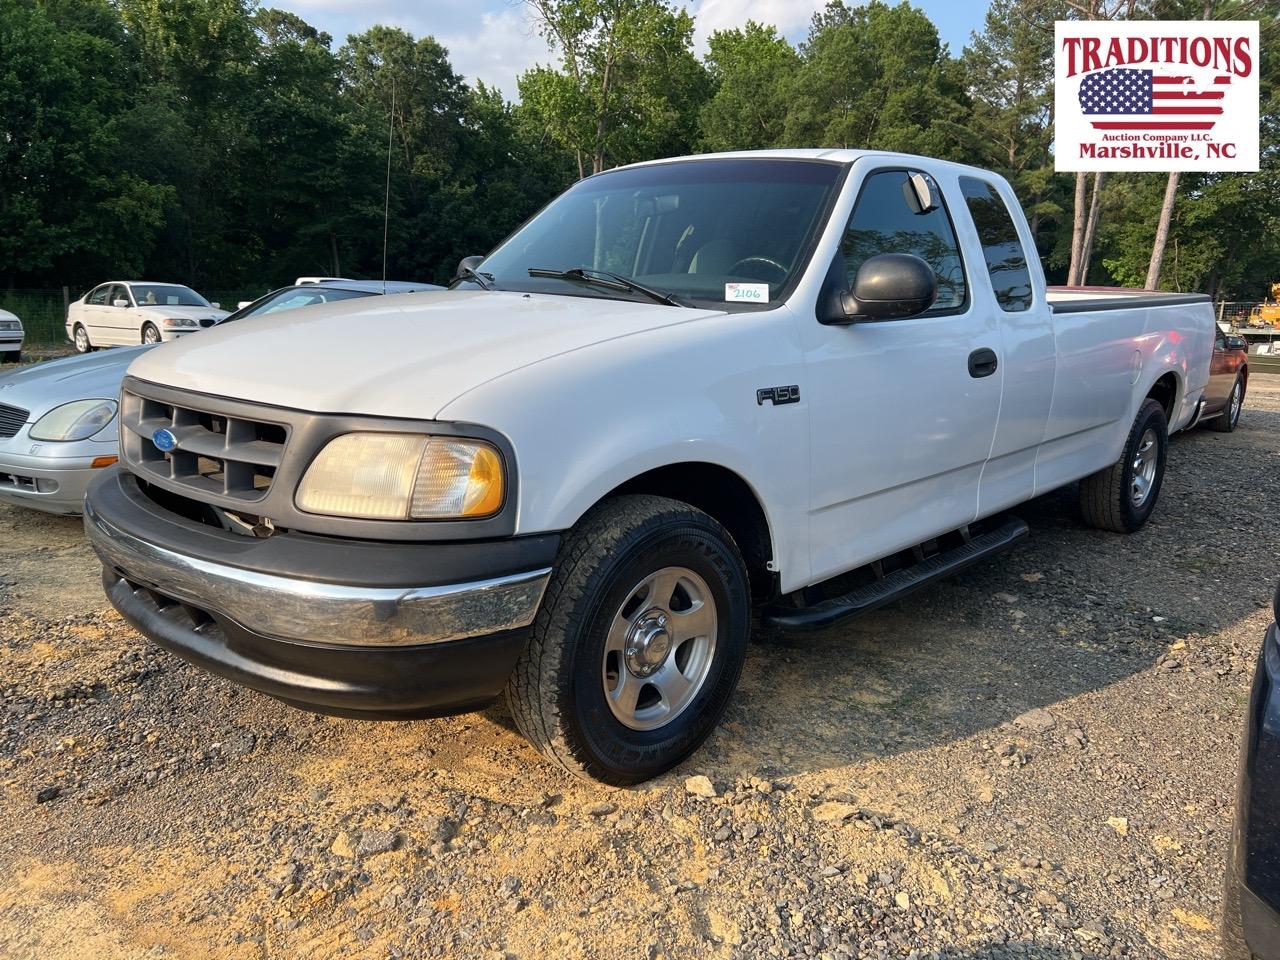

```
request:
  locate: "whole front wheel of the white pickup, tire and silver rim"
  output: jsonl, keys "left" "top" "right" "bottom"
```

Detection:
{"left": 507, "top": 495, "right": 750, "bottom": 786}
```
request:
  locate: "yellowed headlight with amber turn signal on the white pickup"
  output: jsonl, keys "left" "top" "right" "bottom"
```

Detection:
{"left": 297, "top": 434, "right": 506, "bottom": 520}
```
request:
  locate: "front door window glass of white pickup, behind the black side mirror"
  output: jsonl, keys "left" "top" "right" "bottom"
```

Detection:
{"left": 840, "top": 170, "right": 968, "bottom": 312}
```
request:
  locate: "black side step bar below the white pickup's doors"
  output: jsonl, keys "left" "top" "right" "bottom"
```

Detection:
{"left": 763, "top": 517, "right": 1029, "bottom": 630}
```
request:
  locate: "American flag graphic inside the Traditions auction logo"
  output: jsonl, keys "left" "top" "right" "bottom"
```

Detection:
{"left": 1080, "top": 68, "right": 1231, "bottom": 131}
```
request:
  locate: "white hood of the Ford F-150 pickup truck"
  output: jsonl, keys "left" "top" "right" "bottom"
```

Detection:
{"left": 129, "top": 291, "right": 722, "bottom": 420}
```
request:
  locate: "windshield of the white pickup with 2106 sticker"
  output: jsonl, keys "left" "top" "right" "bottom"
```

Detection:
{"left": 471, "top": 159, "right": 844, "bottom": 306}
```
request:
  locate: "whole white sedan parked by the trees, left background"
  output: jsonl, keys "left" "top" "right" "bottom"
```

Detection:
{"left": 67, "top": 280, "right": 228, "bottom": 353}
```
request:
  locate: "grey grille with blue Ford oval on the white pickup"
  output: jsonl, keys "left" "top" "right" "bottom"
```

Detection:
{"left": 120, "top": 387, "right": 289, "bottom": 502}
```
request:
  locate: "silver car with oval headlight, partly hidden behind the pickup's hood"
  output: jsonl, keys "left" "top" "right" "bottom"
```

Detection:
{"left": 0, "top": 280, "right": 442, "bottom": 515}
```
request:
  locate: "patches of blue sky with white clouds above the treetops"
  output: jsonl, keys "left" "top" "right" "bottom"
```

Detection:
{"left": 275, "top": 0, "right": 988, "bottom": 97}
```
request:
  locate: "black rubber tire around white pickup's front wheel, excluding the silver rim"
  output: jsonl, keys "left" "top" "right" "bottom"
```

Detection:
{"left": 507, "top": 495, "right": 750, "bottom": 786}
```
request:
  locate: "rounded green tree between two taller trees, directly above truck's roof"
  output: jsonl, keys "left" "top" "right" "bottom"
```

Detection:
{"left": 699, "top": 20, "right": 800, "bottom": 150}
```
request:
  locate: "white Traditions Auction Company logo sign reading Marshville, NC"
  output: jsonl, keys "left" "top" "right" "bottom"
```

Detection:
{"left": 1053, "top": 20, "right": 1258, "bottom": 170}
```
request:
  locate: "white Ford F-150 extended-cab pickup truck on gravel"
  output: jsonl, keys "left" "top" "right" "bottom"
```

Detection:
{"left": 84, "top": 150, "right": 1213, "bottom": 783}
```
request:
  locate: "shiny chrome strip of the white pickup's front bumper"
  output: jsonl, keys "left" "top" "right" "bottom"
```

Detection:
{"left": 84, "top": 498, "right": 550, "bottom": 646}
